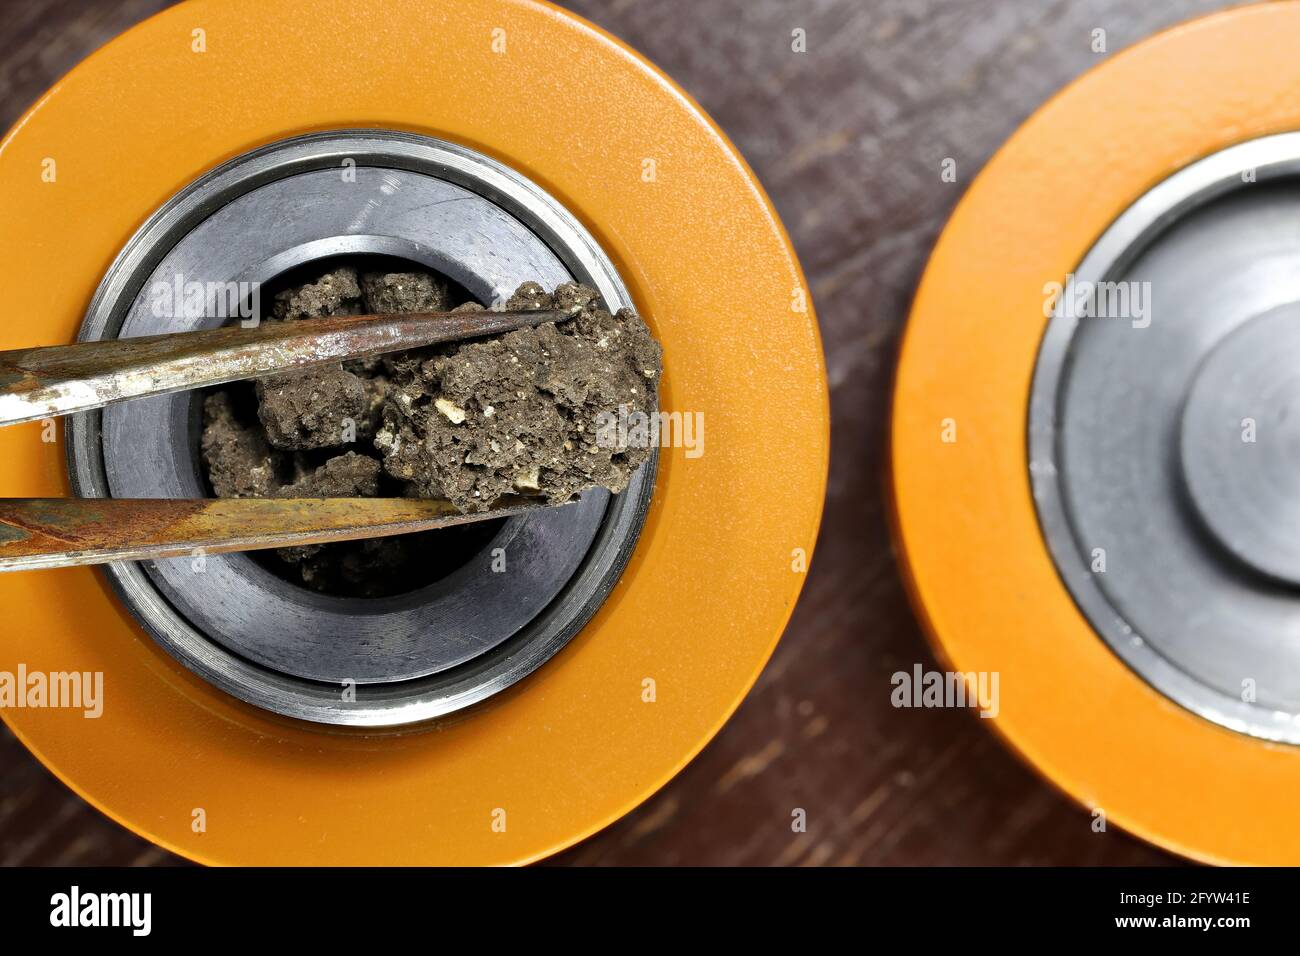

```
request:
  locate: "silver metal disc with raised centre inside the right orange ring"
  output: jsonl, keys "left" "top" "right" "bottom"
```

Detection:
{"left": 1028, "top": 134, "right": 1300, "bottom": 743}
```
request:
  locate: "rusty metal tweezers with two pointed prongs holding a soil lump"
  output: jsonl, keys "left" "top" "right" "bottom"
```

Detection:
{"left": 0, "top": 310, "right": 569, "bottom": 571}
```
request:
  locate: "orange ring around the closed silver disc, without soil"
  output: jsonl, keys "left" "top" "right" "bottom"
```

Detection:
{"left": 892, "top": 3, "right": 1300, "bottom": 864}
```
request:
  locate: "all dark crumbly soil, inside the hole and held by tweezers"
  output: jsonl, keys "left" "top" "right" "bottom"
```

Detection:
{"left": 202, "top": 267, "right": 660, "bottom": 596}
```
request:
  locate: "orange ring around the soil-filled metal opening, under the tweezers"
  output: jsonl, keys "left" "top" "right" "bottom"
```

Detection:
{"left": 0, "top": 0, "right": 828, "bottom": 865}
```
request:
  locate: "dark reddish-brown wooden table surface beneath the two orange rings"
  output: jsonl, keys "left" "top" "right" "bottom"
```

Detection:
{"left": 0, "top": 0, "right": 1223, "bottom": 865}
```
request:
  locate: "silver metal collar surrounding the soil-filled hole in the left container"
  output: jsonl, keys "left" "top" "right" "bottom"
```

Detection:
{"left": 68, "top": 130, "right": 654, "bottom": 726}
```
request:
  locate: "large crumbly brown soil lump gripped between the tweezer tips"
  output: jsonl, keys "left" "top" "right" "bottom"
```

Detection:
{"left": 374, "top": 282, "right": 660, "bottom": 511}
